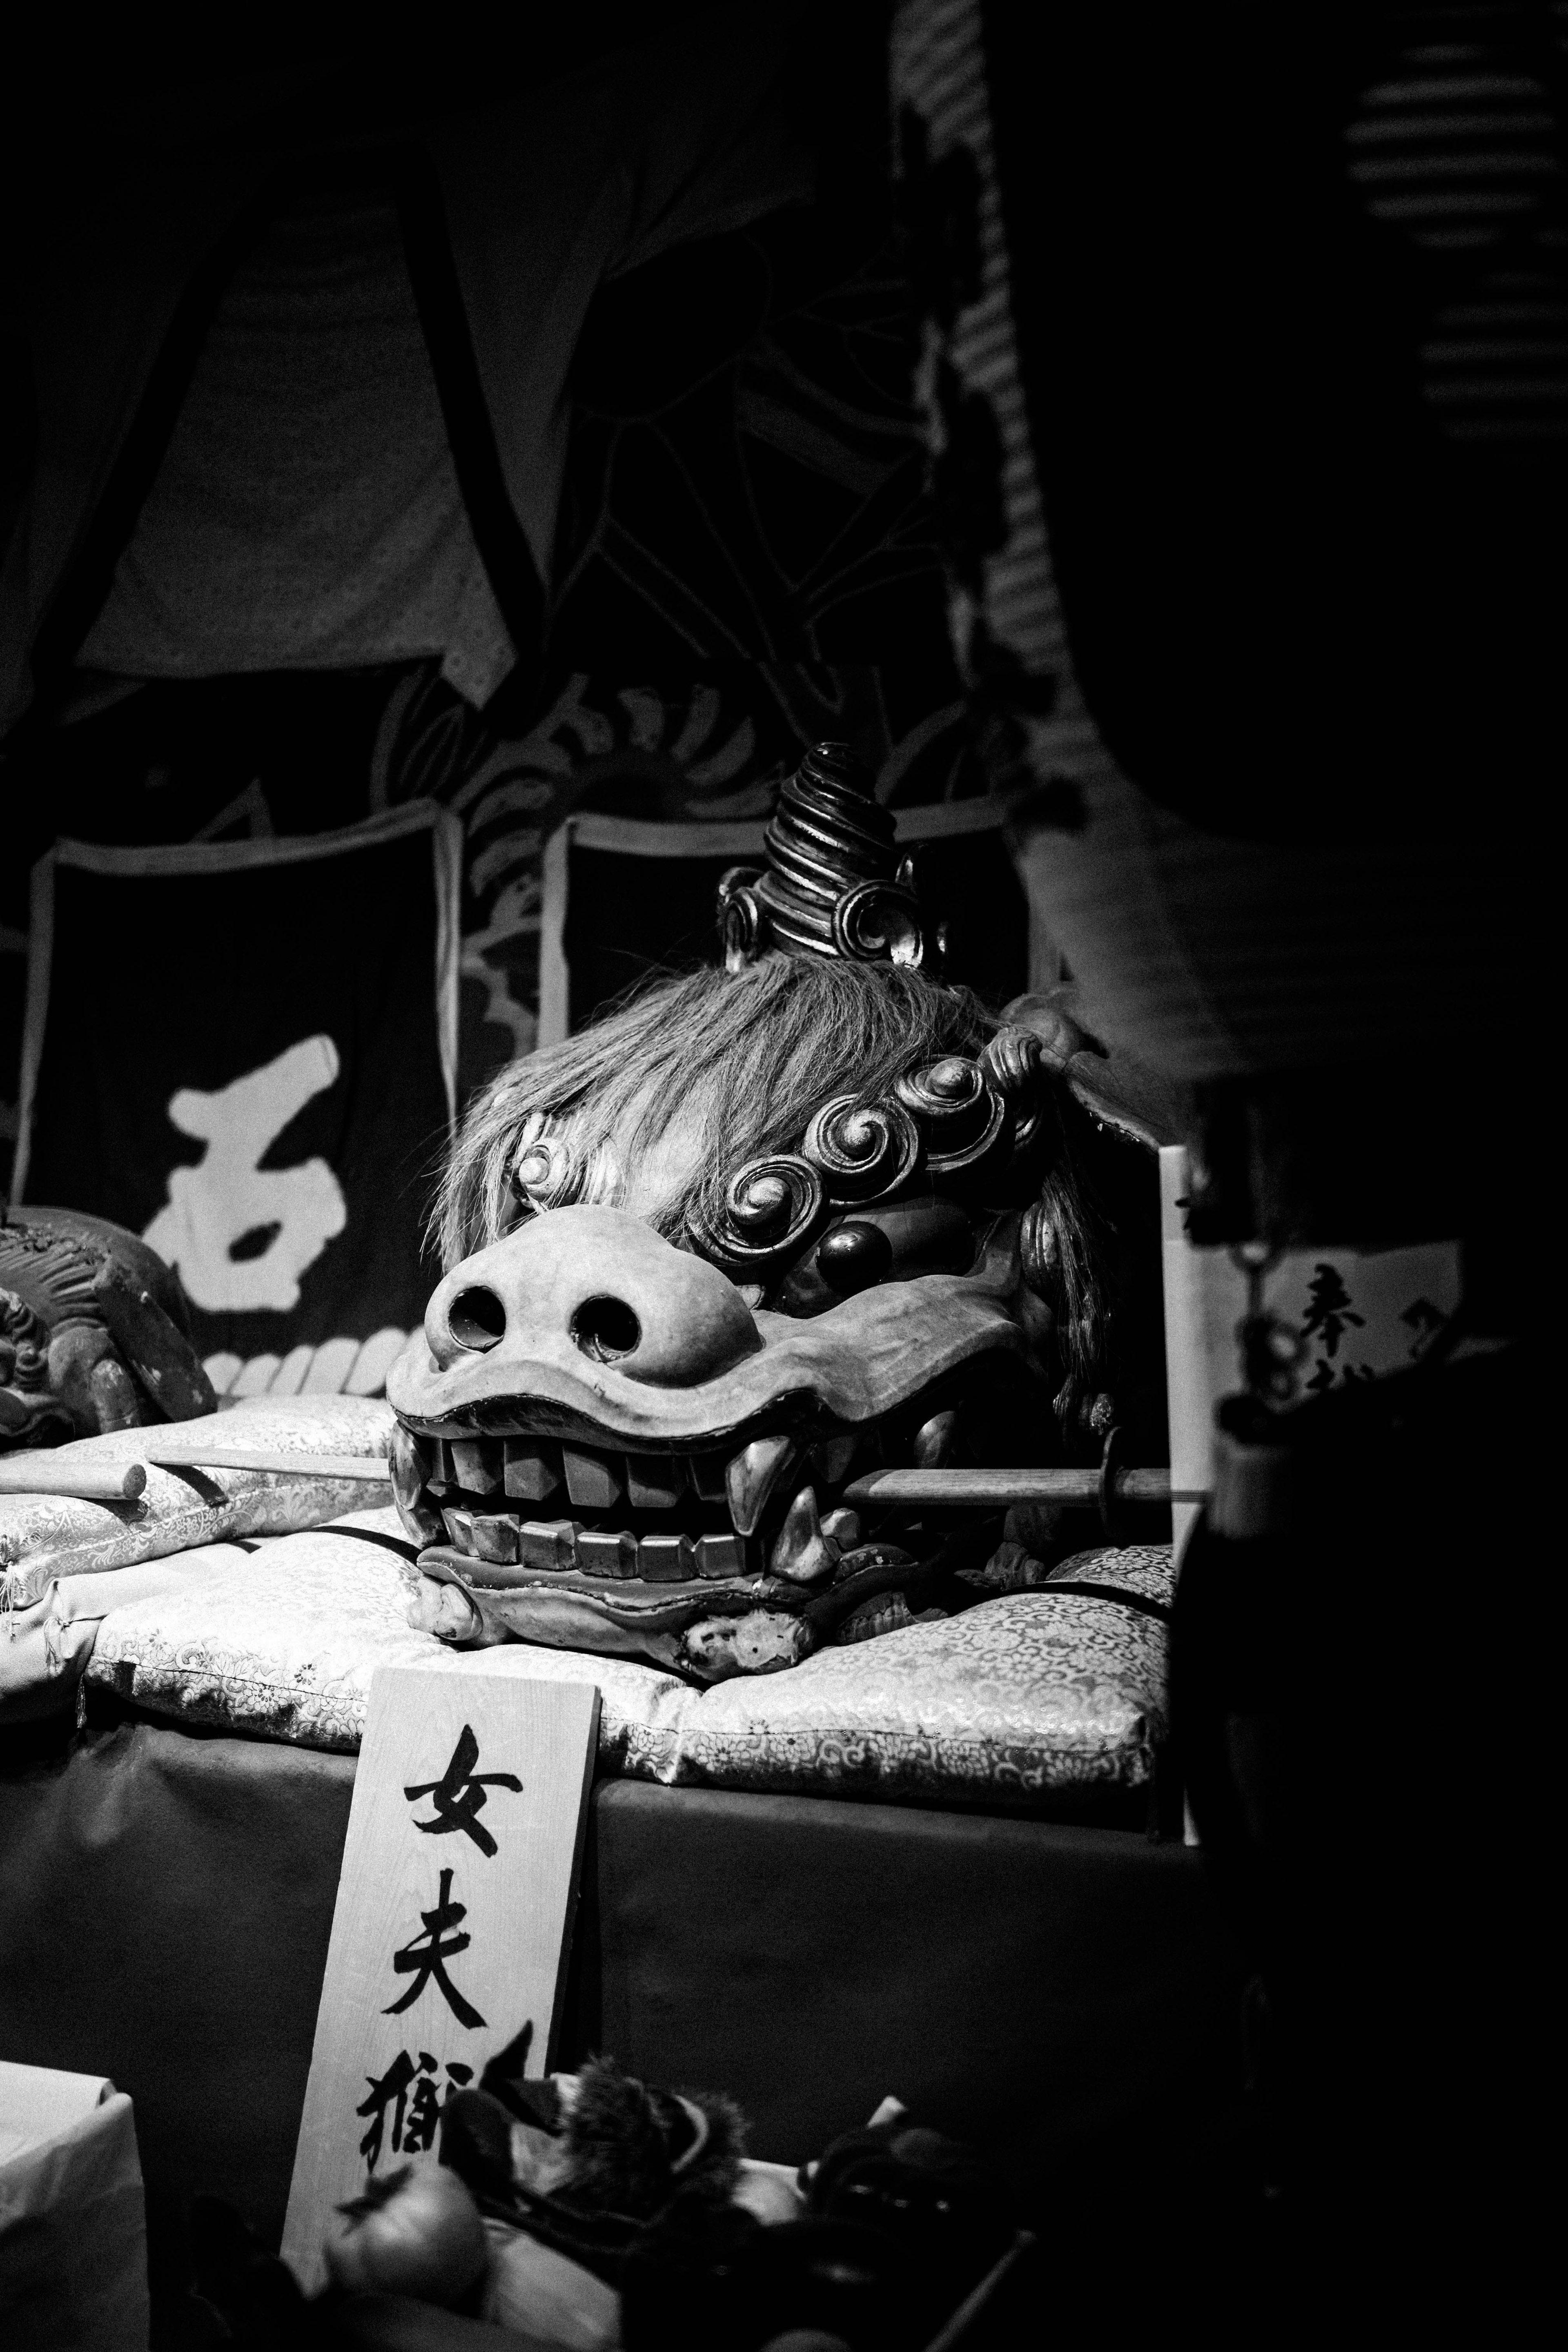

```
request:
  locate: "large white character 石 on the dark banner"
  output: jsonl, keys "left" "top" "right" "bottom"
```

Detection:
{"left": 143, "top": 1035, "right": 348, "bottom": 1312}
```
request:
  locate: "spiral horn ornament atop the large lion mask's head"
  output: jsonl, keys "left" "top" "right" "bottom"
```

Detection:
{"left": 719, "top": 743, "right": 943, "bottom": 978}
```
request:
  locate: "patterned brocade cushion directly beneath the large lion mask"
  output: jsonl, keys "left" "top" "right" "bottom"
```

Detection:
{"left": 87, "top": 1510, "right": 1173, "bottom": 1804}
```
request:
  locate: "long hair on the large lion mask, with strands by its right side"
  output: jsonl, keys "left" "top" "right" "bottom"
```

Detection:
{"left": 430, "top": 955, "right": 1107, "bottom": 1388}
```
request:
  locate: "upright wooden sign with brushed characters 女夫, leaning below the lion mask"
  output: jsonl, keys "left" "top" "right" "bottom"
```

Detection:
{"left": 282, "top": 1661, "right": 599, "bottom": 2293}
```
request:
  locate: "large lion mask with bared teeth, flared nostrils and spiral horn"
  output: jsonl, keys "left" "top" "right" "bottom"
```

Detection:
{"left": 388, "top": 743, "right": 1152, "bottom": 1682}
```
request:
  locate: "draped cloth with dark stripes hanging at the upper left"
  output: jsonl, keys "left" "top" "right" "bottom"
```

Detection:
{"left": 0, "top": 5, "right": 811, "bottom": 727}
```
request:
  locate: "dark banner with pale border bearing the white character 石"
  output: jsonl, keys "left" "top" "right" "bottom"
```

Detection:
{"left": 16, "top": 807, "right": 461, "bottom": 1395}
